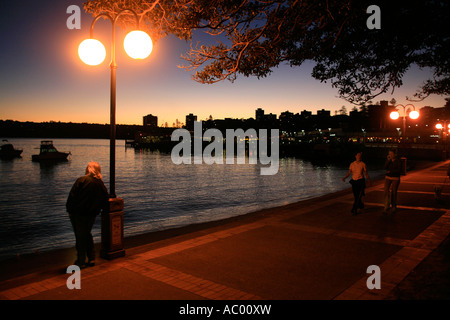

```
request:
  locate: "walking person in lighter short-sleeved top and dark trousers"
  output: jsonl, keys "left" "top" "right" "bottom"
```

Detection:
{"left": 342, "top": 152, "right": 370, "bottom": 215}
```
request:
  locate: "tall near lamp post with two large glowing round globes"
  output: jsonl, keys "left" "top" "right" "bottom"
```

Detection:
{"left": 78, "top": 9, "right": 153, "bottom": 259}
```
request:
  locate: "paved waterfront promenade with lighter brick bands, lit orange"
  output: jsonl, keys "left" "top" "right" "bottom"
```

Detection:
{"left": 0, "top": 162, "right": 450, "bottom": 300}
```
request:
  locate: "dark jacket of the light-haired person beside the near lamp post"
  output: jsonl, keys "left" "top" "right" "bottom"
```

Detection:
{"left": 66, "top": 175, "right": 109, "bottom": 215}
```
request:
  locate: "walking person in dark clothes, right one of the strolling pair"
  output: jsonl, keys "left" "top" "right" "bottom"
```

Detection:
{"left": 383, "top": 150, "right": 402, "bottom": 213}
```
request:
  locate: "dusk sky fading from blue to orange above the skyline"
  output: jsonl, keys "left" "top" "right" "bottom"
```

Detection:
{"left": 0, "top": 0, "right": 445, "bottom": 126}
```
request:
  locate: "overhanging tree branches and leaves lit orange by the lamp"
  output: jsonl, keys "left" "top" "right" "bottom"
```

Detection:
{"left": 85, "top": 0, "right": 450, "bottom": 104}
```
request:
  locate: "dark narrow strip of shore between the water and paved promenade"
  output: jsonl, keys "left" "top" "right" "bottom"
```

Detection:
{"left": 0, "top": 161, "right": 438, "bottom": 281}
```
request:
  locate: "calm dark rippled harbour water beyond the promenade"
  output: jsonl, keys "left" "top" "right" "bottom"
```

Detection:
{"left": 0, "top": 139, "right": 384, "bottom": 259}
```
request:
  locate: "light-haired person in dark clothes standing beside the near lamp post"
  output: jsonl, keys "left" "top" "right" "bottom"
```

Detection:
{"left": 66, "top": 161, "right": 109, "bottom": 268}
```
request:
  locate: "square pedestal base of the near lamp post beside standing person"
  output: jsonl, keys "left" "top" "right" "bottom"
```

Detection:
{"left": 100, "top": 198, "right": 125, "bottom": 260}
